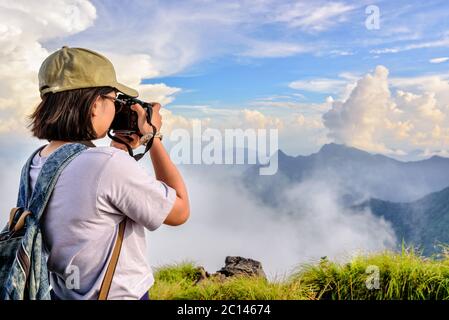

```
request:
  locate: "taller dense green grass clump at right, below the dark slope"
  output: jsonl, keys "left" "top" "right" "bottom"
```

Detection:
{"left": 291, "top": 249, "right": 449, "bottom": 300}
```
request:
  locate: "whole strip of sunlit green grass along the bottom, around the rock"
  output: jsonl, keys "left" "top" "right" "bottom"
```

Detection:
{"left": 150, "top": 249, "right": 449, "bottom": 300}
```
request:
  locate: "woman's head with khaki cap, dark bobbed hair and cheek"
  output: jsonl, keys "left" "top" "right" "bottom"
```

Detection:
{"left": 28, "top": 47, "right": 138, "bottom": 141}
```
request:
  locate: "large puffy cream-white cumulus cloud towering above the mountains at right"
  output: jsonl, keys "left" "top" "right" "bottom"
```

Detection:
{"left": 323, "top": 66, "right": 449, "bottom": 154}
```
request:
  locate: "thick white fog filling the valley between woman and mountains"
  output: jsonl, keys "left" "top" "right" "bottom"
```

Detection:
{"left": 148, "top": 165, "right": 396, "bottom": 279}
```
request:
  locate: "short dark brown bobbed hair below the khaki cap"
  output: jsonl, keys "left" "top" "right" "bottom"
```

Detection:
{"left": 27, "top": 87, "right": 115, "bottom": 141}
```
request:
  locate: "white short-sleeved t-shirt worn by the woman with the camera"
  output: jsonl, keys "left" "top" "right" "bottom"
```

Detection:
{"left": 30, "top": 147, "right": 176, "bottom": 300}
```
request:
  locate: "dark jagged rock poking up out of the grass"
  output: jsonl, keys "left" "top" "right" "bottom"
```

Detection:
{"left": 217, "top": 256, "right": 267, "bottom": 279}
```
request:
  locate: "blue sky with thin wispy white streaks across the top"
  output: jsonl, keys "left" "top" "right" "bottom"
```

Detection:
{"left": 46, "top": 1, "right": 449, "bottom": 99}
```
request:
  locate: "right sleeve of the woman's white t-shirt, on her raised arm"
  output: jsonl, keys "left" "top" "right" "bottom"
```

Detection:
{"left": 97, "top": 150, "right": 176, "bottom": 231}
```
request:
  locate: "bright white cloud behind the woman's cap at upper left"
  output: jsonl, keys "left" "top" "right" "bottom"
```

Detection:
{"left": 0, "top": 0, "right": 184, "bottom": 138}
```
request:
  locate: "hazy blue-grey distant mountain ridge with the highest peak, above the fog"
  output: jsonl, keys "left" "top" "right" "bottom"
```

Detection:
{"left": 243, "top": 143, "right": 449, "bottom": 204}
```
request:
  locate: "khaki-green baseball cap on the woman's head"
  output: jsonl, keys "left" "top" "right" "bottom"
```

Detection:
{"left": 39, "top": 46, "right": 139, "bottom": 97}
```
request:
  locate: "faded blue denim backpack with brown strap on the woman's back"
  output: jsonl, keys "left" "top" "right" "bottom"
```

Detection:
{"left": 0, "top": 141, "right": 126, "bottom": 300}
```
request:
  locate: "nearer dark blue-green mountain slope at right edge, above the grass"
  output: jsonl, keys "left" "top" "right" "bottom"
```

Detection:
{"left": 355, "top": 188, "right": 449, "bottom": 255}
